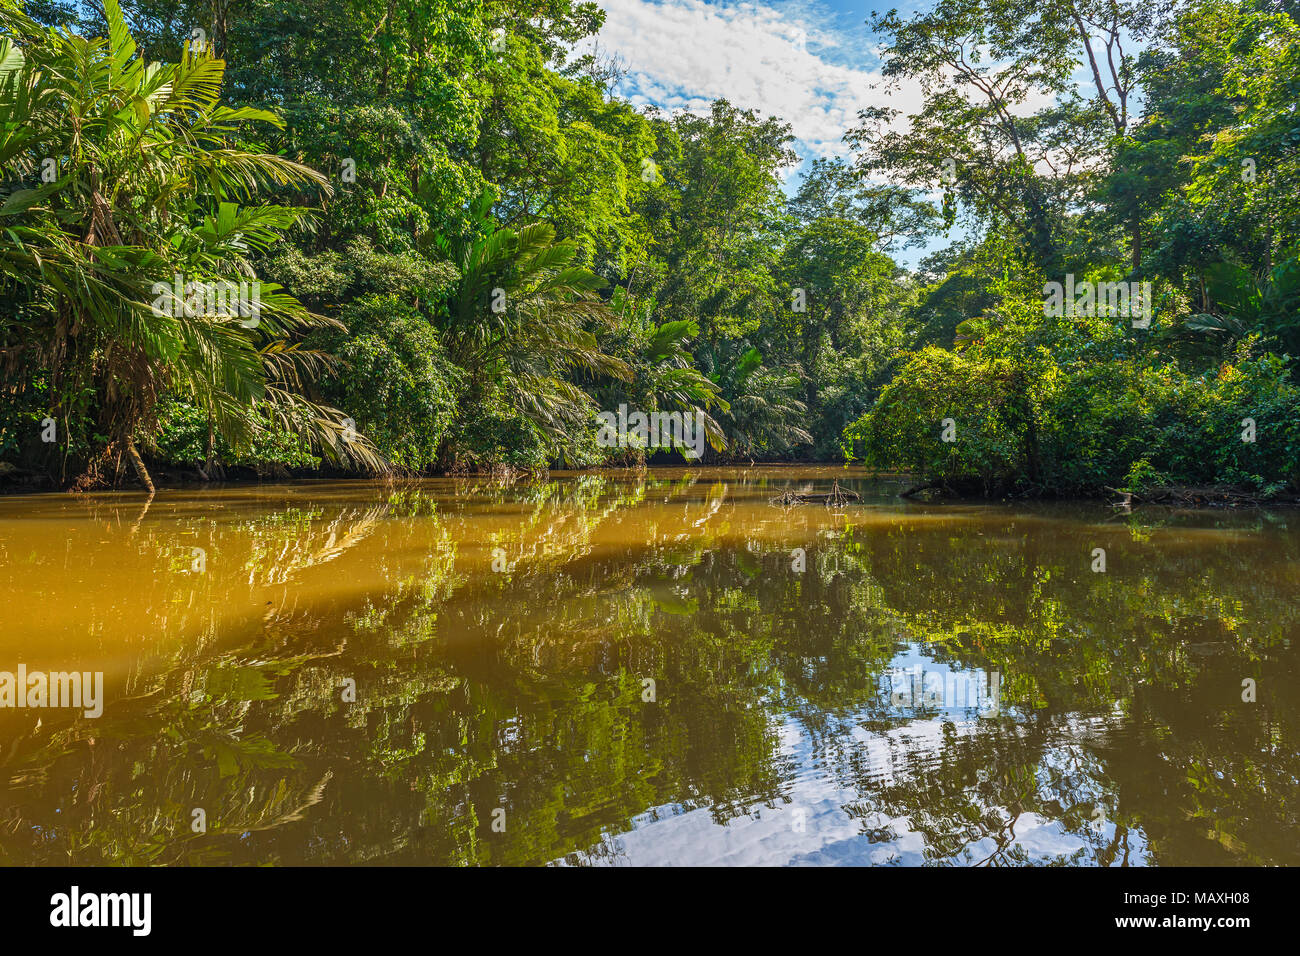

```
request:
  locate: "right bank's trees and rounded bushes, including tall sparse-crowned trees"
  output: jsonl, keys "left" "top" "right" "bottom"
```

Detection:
{"left": 845, "top": 0, "right": 1300, "bottom": 494}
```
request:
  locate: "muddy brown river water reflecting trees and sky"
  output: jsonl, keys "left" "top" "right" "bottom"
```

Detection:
{"left": 0, "top": 467, "right": 1300, "bottom": 866}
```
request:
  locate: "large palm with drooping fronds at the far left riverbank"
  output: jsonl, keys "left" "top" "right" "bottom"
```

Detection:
{"left": 0, "top": 0, "right": 384, "bottom": 490}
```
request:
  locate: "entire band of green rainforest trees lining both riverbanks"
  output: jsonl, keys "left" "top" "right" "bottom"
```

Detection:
{"left": 0, "top": 0, "right": 1300, "bottom": 493}
